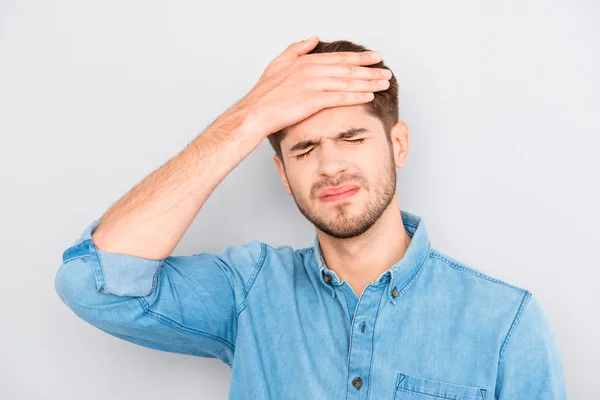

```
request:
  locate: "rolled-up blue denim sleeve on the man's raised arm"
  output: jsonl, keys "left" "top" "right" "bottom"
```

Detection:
{"left": 54, "top": 219, "right": 266, "bottom": 367}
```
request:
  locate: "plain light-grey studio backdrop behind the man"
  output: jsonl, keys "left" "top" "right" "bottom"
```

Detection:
{"left": 0, "top": 0, "right": 600, "bottom": 400}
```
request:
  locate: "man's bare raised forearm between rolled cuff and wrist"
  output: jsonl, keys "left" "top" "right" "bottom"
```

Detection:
{"left": 92, "top": 104, "right": 265, "bottom": 260}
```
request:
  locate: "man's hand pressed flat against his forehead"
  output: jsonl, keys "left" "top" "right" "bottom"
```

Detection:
{"left": 233, "top": 36, "right": 392, "bottom": 138}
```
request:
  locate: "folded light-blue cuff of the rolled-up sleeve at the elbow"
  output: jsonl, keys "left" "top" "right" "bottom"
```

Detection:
{"left": 62, "top": 218, "right": 163, "bottom": 296}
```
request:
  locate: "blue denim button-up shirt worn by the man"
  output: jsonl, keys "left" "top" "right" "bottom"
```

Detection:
{"left": 55, "top": 211, "right": 566, "bottom": 400}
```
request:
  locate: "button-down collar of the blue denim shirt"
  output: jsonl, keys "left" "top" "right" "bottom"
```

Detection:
{"left": 313, "top": 210, "right": 431, "bottom": 304}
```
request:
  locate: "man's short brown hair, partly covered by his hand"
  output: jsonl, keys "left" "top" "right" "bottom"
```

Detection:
{"left": 267, "top": 40, "right": 399, "bottom": 161}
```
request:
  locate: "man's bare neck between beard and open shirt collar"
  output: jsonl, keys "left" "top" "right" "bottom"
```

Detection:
{"left": 317, "top": 196, "right": 411, "bottom": 297}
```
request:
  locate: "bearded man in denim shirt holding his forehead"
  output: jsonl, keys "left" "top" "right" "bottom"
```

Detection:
{"left": 56, "top": 37, "right": 566, "bottom": 400}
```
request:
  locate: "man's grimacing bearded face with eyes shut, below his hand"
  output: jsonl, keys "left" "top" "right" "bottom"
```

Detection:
{"left": 275, "top": 105, "right": 403, "bottom": 239}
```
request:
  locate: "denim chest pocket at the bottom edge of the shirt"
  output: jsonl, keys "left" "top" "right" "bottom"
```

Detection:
{"left": 394, "top": 373, "right": 487, "bottom": 400}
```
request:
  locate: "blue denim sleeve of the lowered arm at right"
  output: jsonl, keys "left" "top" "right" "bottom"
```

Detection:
{"left": 496, "top": 291, "right": 567, "bottom": 400}
